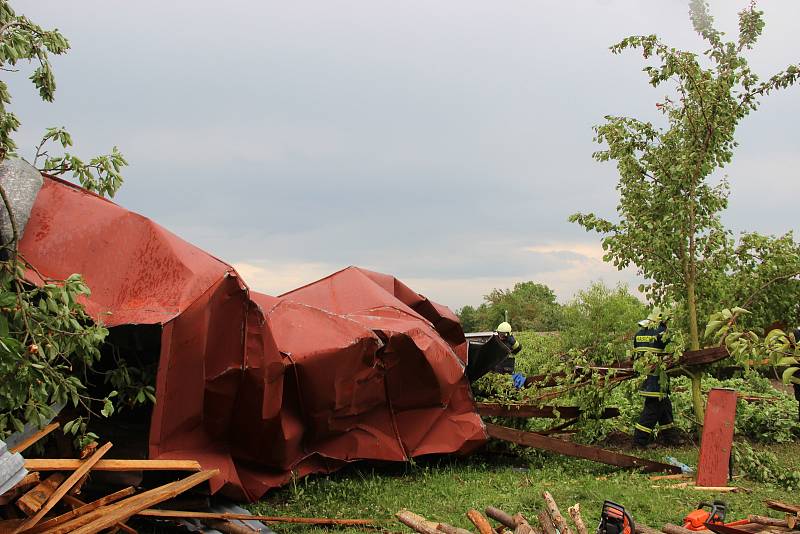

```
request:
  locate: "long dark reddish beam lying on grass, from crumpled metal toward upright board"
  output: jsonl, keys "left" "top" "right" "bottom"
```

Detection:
{"left": 486, "top": 423, "right": 680, "bottom": 473}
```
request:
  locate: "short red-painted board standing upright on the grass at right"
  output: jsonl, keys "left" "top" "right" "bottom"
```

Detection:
{"left": 697, "top": 389, "right": 736, "bottom": 486}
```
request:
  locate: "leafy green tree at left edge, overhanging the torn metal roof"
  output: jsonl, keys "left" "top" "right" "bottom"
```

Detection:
{"left": 0, "top": 0, "right": 136, "bottom": 443}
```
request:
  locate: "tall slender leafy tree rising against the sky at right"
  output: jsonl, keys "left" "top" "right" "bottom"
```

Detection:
{"left": 570, "top": 0, "right": 800, "bottom": 422}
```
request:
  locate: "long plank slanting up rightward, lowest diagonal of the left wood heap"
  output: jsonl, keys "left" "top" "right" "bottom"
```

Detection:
{"left": 48, "top": 469, "right": 219, "bottom": 534}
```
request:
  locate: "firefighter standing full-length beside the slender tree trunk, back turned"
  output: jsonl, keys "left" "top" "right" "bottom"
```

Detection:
{"left": 633, "top": 308, "right": 677, "bottom": 447}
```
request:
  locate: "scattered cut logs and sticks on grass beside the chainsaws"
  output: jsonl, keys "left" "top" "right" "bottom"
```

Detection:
{"left": 395, "top": 491, "right": 800, "bottom": 534}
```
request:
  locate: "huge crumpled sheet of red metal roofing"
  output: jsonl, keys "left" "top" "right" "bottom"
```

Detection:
{"left": 20, "top": 177, "right": 486, "bottom": 500}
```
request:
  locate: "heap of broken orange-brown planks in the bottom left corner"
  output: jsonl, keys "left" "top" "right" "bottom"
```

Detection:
{"left": 0, "top": 423, "right": 374, "bottom": 534}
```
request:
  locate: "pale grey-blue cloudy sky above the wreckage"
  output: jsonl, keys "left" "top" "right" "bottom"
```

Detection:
{"left": 4, "top": 0, "right": 800, "bottom": 308}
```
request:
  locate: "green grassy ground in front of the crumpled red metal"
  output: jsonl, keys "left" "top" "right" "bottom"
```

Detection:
{"left": 250, "top": 443, "right": 800, "bottom": 533}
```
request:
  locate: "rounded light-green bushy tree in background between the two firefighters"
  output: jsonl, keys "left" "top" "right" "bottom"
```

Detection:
{"left": 561, "top": 282, "right": 648, "bottom": 363}
